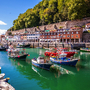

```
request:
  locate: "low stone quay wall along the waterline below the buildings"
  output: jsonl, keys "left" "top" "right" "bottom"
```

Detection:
{"left": 5, "top": 42, "right": 90, "bottom": 49}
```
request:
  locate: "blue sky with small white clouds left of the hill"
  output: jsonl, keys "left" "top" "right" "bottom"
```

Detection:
{"left": 0, "top": 0, "right": 42, "bottom": 35}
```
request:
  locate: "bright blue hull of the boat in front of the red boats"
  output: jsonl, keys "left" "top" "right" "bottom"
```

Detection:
{"left": 50, "top": 58, "right": 78, "bottom": 66}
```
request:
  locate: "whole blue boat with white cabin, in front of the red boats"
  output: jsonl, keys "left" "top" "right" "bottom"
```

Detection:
{"left": 50, "top": 53, "right": 78, "bottom": 66}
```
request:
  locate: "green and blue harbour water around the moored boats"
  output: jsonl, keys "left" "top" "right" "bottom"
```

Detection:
{"left": 0, "top": 48, "right": 90, "bottom": 90}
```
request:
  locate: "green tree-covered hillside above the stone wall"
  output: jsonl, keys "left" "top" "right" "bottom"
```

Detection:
{"left": 8, "top": 0, "right": 90, "bottom": 30}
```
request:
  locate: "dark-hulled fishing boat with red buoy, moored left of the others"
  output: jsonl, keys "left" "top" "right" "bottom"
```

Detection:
{"left": 8, "top": 49, "right": 29, "bottom": 60}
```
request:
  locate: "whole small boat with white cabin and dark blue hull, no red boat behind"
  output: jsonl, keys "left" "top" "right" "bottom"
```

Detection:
{"left": 32, "top": 56, "right": 53, "bottom": 70}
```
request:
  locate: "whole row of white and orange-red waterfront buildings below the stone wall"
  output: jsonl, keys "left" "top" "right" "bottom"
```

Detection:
{"left": 5, "top": 27, "right": 83, "bottom": 43}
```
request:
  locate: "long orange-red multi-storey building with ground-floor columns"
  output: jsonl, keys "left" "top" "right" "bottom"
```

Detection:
{"left": 40, "top": 27, "right": 82, "bottom": 43}
